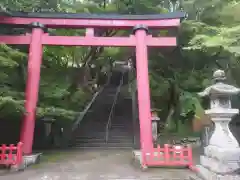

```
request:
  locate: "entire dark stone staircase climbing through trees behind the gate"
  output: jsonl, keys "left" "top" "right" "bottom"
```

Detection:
{"left": 71, "top": 71, "right": 134, "bottom": 148}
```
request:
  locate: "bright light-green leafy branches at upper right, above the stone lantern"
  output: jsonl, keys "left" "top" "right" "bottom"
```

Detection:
{"left": 183, "top": 0, "right": 240, "bottom": 56}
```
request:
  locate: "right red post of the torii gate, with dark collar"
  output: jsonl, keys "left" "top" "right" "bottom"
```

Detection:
{"left": 134, "top": 26, "right": 153, "bottom": 159}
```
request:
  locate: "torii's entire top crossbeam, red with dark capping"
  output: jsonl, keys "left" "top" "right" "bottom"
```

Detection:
{"left": 0, "top": 12, "right": 186, "bottom": 29}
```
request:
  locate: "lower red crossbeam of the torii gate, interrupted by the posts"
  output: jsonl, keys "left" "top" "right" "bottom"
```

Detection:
{"left": 0, "top": 34, "right": 177, "bottom": 47}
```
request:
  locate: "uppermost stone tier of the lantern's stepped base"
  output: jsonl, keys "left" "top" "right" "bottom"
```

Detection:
{"left": 204, "top": 145, "right": 240, "bottom": 163}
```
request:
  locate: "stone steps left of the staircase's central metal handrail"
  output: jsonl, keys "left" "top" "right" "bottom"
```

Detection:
{"left": 73, "top": 85, "right": 117, "bottom": 148}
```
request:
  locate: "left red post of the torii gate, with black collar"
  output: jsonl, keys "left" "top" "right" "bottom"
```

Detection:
{"left": 21, "top": 23, "right": 44, "bottom": 154}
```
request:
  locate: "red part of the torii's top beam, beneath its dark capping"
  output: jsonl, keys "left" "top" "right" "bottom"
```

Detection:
{"left": 0, "top": 16, "right": 180, "bottom": 29}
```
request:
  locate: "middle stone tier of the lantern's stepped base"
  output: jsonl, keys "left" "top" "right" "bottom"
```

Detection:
{"left": 200, "top": 156, "right": 239, "bottom": 174}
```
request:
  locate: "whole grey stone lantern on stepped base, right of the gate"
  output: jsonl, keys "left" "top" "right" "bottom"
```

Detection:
{"left": 197, "top": 70, "right": 240, "bottom": 180}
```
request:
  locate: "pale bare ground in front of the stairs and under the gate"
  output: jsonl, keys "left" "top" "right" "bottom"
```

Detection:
{"left": 0, "top": 150, "right": 196, "bottom": 180}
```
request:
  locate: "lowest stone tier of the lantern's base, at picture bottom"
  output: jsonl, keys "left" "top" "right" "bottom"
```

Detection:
{"left": 197, "top": 165, "right": 240, "bottom": 180}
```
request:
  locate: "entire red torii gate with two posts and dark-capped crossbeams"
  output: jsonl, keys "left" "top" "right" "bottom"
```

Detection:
{"left": 0, "top": 12, "right": 185, "bottom": 167}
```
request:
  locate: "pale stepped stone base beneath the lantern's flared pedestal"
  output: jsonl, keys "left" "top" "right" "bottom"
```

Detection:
{"left": 191, "top": 145, "right": 240, "bottom": 180}
